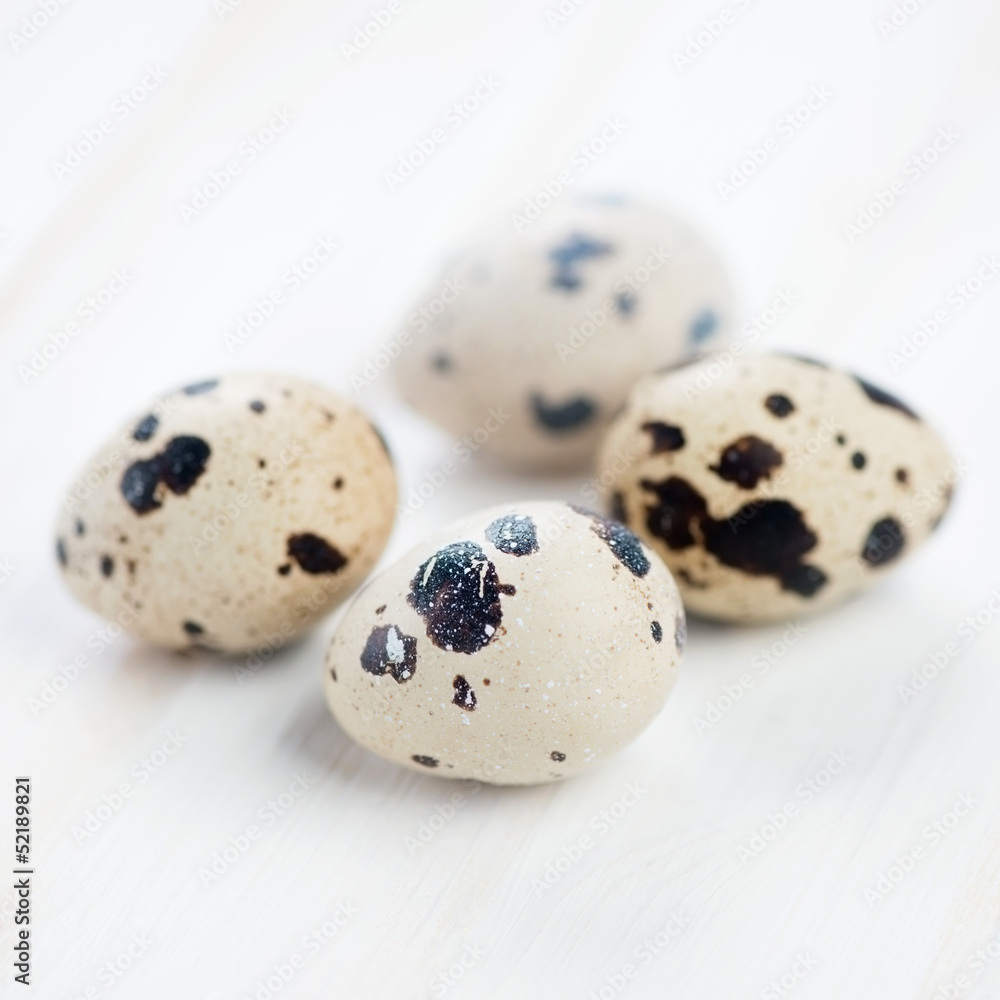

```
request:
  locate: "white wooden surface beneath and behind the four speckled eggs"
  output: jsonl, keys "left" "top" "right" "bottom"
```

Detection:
{"left": 0, "top": 0, "right": 1000, "bottom": 1000}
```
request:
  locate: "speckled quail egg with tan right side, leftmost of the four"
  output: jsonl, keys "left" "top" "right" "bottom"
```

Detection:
{"left": 56, "top": 374, "right": 396, "bottom": 653}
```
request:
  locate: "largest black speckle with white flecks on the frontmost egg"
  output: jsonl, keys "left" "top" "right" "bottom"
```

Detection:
{"left": 407, "top": 542, "right": 503, "bottom": 654}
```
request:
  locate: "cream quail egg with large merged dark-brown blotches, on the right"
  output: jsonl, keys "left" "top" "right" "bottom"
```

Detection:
{"left": 593, "top": 354, "right": 959, "bottom": 622}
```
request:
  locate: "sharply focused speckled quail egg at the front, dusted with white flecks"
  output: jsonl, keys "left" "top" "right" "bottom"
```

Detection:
{"left": 325, "top": 501, "right": 685, "bottom": 784}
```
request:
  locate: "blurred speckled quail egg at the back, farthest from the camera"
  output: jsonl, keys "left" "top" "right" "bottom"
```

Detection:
{"left": 394, "top": 198, "right": 733, "bottom": 469}
